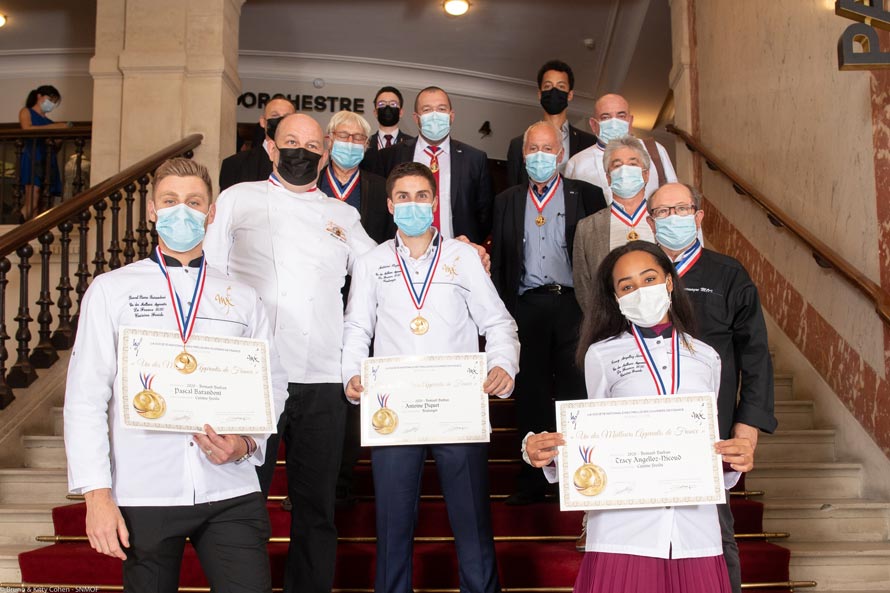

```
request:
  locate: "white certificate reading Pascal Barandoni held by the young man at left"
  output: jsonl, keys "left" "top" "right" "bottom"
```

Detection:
{"left": 118, "top": 327, "right": 276, "bottom": 434}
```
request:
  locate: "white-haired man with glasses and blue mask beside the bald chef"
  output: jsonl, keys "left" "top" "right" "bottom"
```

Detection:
{"left": 318, "top": 111, "right": 396, "bottom": 243}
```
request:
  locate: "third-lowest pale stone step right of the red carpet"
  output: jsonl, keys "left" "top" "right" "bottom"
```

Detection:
{"left": 745, "top": 462, "right": 862, "bottom": 502}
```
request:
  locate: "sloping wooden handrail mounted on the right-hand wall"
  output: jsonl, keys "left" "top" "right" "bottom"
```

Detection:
{"left": 666, "top": 124, "right": 890, "bottom": 325}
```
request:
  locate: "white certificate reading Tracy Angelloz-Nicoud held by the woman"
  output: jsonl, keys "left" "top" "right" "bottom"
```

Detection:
{"left": 556, "top": 393, "right": 725, "bottom": 510}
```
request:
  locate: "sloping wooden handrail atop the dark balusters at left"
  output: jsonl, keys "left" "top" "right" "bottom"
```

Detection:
{"left": 0, "top": 135, "right": 204, "bottom": 258}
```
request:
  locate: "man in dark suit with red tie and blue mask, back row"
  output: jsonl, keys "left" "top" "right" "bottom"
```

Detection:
{"left": 375, "top": 87, "right": 492, "bottom": 244}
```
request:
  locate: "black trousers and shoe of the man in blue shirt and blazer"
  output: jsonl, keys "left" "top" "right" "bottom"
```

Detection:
{"left": 513, "top": 292, "right": 587, "bottom": 496}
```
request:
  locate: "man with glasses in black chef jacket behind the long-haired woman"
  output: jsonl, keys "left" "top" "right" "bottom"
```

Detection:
{"left": 647, "top": 183, "right": 777, "bottom": 593}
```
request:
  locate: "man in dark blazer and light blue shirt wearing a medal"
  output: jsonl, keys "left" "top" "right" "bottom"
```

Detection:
{"left": 491, "top": 121, "right": 606, "bottom": 504}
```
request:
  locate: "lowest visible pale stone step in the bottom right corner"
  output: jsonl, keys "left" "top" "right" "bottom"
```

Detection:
{"left": 783, "top": 541, "right": 890, "bottom": 593}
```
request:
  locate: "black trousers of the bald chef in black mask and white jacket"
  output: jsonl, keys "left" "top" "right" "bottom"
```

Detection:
{"left": 279, "top": 383, "right": 350, "bottom": 593}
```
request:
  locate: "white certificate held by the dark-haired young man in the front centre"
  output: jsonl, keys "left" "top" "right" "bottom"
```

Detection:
{"left": 361, "top": 353, "right": 489, "bottom": 447}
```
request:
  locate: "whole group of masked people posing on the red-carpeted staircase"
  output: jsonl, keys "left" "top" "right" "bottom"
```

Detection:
{"left": 64, "top": 56, "right": 776, "bottom": 593}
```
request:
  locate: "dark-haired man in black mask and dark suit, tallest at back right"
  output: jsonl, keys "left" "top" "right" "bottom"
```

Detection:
{"left": 507, "top": 60, "right": 596, "bottom": 185}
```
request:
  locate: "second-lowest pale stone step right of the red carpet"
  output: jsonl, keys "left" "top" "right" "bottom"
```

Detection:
{"left": 763, "top": 498, "right": 890, "bottom": 544}
